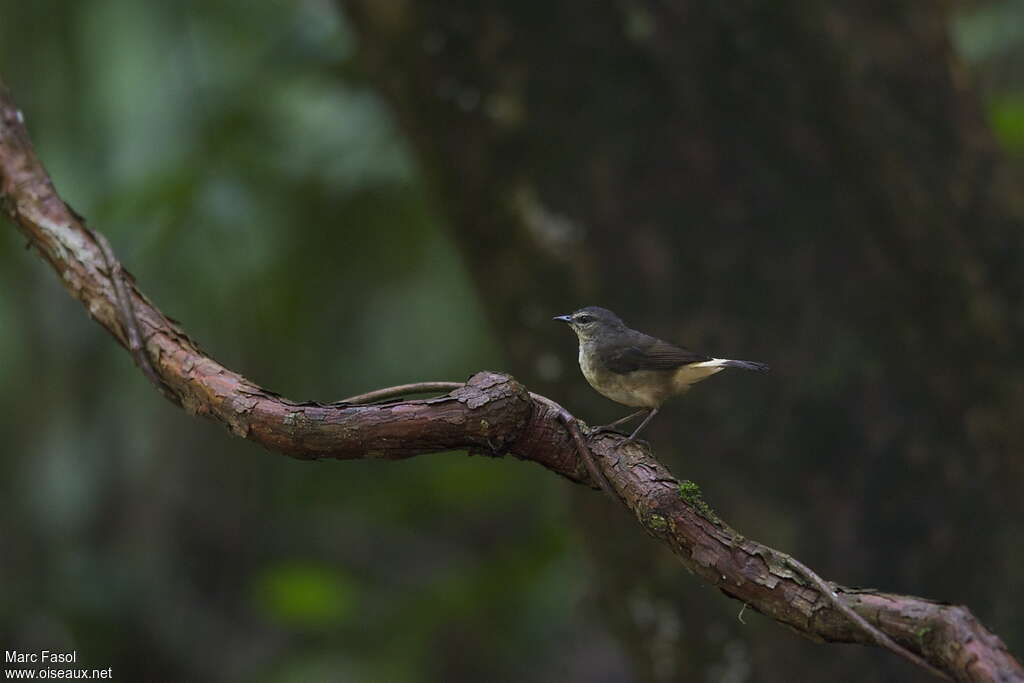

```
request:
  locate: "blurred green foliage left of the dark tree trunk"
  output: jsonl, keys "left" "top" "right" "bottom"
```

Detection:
{"left": 0, "top": 0, "right": 606, "bottom": 681}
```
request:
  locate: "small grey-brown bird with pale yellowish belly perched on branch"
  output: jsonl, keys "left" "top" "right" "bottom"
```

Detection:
{"left": 554, "top": 306, "right": 768, "bottom": 443}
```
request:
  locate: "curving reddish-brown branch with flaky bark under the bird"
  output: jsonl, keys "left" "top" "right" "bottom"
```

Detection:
{"left": 0, "top": 76, "right": 1024, "bottom": 683}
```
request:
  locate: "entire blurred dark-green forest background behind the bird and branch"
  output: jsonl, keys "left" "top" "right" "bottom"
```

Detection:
{"left": 0, "top": 0, "right": 1024, "bottom": 683}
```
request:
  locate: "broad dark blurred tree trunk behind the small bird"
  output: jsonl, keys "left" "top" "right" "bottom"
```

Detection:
{"left": 345, "top": 0, "right": 1024, "bottom": 681}
